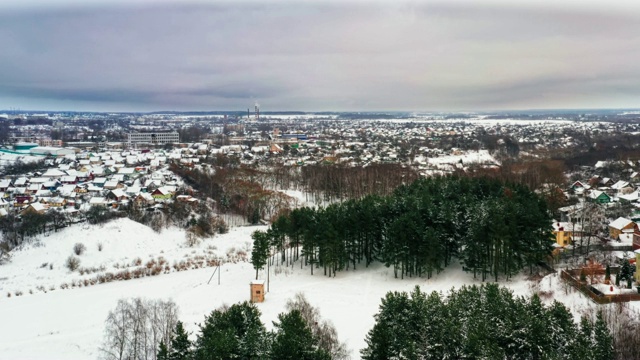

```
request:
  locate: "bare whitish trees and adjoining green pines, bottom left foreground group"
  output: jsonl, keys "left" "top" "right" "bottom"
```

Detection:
{"left": 100, "top": 294, "right": 348, "bottom": 360}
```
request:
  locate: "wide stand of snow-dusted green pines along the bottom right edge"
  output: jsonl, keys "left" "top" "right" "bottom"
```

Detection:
{"left": 361, "top": 284, "right": 615, "bottom": 360}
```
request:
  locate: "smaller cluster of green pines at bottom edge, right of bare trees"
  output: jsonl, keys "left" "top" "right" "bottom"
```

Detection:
{"left": 157, "top": 295, "right": 348, "bottom": 360}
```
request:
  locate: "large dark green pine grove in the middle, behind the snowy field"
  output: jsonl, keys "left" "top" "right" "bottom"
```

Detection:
{"left": 252, "top": 176, "right": 553, "bottom": 281}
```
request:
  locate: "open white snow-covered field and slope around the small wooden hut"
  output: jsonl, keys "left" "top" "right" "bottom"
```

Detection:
{"left": 0, "top": 219, "right": 632, "bottom": 359}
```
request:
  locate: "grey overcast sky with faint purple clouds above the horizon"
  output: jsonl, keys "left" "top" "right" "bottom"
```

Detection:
{"left": 0, "top": 0, "right": 640, "bottom": 111}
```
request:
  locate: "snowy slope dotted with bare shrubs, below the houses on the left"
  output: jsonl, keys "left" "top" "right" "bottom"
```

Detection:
{"left": 0, "top": 218, "right": 260, "bottom": 297}
